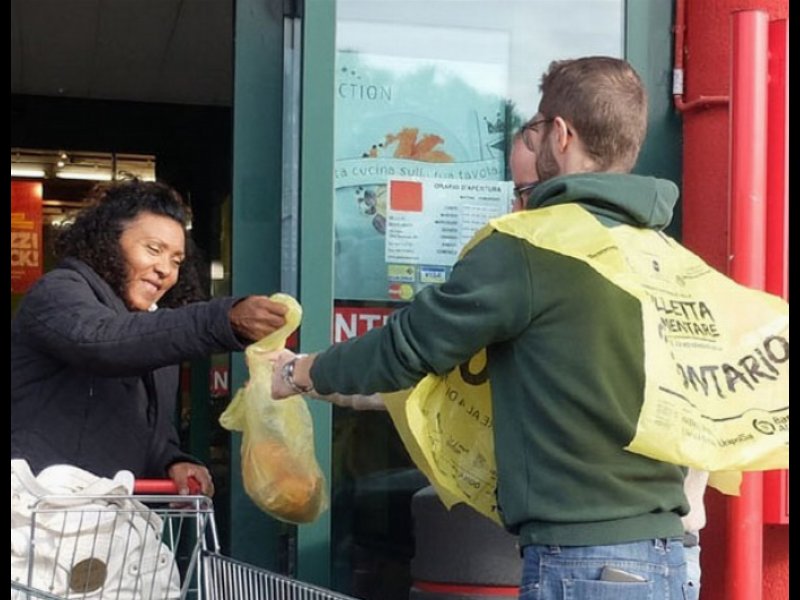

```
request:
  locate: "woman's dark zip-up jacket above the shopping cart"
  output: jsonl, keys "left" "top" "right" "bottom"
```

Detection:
{"left": 11, "top": 259, "right": 243, "bottom": 477}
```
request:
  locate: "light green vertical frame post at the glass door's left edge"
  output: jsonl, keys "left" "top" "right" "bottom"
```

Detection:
{"left": 297, "top": 0, "right": 336, "bottom": 586}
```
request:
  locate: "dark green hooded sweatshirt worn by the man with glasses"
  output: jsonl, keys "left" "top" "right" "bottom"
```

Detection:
{"left": 311, "top": 174, "right": 688, "bottom": 546}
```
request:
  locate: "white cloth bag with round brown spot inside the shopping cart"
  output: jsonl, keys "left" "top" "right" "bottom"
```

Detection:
{"left": 11, "top": 460, "right": 181, "bottom": 600}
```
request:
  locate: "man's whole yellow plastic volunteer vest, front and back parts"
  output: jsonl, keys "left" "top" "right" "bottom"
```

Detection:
{"left": 384, "top": 205, "right": 789, "bottom": 521}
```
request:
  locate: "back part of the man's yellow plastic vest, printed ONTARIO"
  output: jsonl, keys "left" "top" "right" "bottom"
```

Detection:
{"left": 492, "top": 205, "right": 789, "bottom": 476}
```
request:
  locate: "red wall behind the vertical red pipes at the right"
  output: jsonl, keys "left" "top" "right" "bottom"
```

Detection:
{"left": 675, "top": 0, "right": 789, "bottom": 600}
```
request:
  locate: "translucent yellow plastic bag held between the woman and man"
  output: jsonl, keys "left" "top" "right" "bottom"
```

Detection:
{"left": 219, "top": 294, "right": 328, "bottom": 523}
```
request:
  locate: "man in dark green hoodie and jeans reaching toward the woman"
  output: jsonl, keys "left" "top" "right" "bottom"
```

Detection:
{"left": 273, "top": 57, "right": 688, "bottom": 600}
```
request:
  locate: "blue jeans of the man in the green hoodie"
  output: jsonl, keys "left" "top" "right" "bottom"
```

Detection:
{"left": 519, "top": 538, "right": 691, "bottom": 600}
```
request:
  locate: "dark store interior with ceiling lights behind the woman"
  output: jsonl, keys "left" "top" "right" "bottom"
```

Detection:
{"left": 10, "top": 0, "right": 234, "bottom": 552}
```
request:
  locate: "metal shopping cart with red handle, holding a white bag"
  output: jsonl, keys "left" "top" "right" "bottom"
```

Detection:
{"left": 11, "top": 480, "right": 355, "bottom": 600}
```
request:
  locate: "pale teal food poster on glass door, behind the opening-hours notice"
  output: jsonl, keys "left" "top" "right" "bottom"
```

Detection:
{"left": 334, "top": 51, "right": 511, "bottom": 301}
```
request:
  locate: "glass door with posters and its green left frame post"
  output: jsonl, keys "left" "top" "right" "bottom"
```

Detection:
{"left": 298, "top": 0, "right": 625, "bottom": 600}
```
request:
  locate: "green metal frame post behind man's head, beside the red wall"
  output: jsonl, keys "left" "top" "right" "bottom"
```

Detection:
{"left": 625, "top": 0, "right": 683, "bottom": 236}
